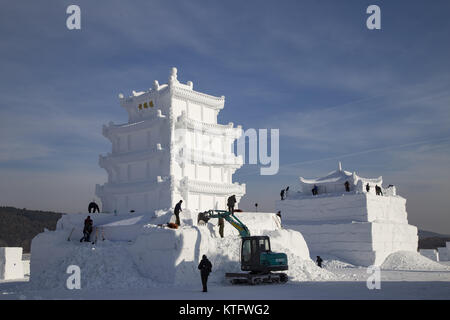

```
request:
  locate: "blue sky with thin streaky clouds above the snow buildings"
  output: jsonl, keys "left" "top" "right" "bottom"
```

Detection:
{"left": 0, "top": 0, "right": 450, "bottom": 234}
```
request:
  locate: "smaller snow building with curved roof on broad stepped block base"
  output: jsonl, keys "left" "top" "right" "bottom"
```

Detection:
{"left": 277, "top": 164, "right": 418, "bottom": 266}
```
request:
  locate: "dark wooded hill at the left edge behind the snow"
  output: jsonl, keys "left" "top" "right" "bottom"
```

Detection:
{"left": 0, "top": 207, "right": 61, "bottom": 253}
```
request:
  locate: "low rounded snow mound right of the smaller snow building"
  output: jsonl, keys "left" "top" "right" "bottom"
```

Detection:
{"left": 381, "top": 251, "right": 450, "bottom": 271}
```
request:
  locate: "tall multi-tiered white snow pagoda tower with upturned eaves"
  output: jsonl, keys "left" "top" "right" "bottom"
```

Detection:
{"left": 96, "top": 68, "right": 245, "bottom": 213}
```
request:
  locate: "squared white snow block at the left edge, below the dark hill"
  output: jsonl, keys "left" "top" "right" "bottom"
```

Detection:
{"left": 0, "top": 247, "right": 24, "bottom": 280}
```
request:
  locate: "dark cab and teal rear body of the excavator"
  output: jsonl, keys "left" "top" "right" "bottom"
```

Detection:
{"left": 241, "top": 236, "right": 288, "bottom": 273}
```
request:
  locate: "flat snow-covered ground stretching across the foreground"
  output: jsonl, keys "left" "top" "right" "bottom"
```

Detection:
{"left": 0, "top": 261, "right": 450, "bottom": 300}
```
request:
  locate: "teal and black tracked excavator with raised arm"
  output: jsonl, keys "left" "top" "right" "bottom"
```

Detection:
{"left": 198, "top": 210, "right": 288, "bottom": 284}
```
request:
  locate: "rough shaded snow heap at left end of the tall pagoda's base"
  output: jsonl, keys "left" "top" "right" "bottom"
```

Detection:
{"left": 31, "top": 232, "right": 151, "bottom": 289}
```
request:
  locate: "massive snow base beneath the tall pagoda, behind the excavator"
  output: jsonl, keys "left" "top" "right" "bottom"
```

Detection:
{"left": 30, "top": 212, "right": 333, "bottom": 289}
